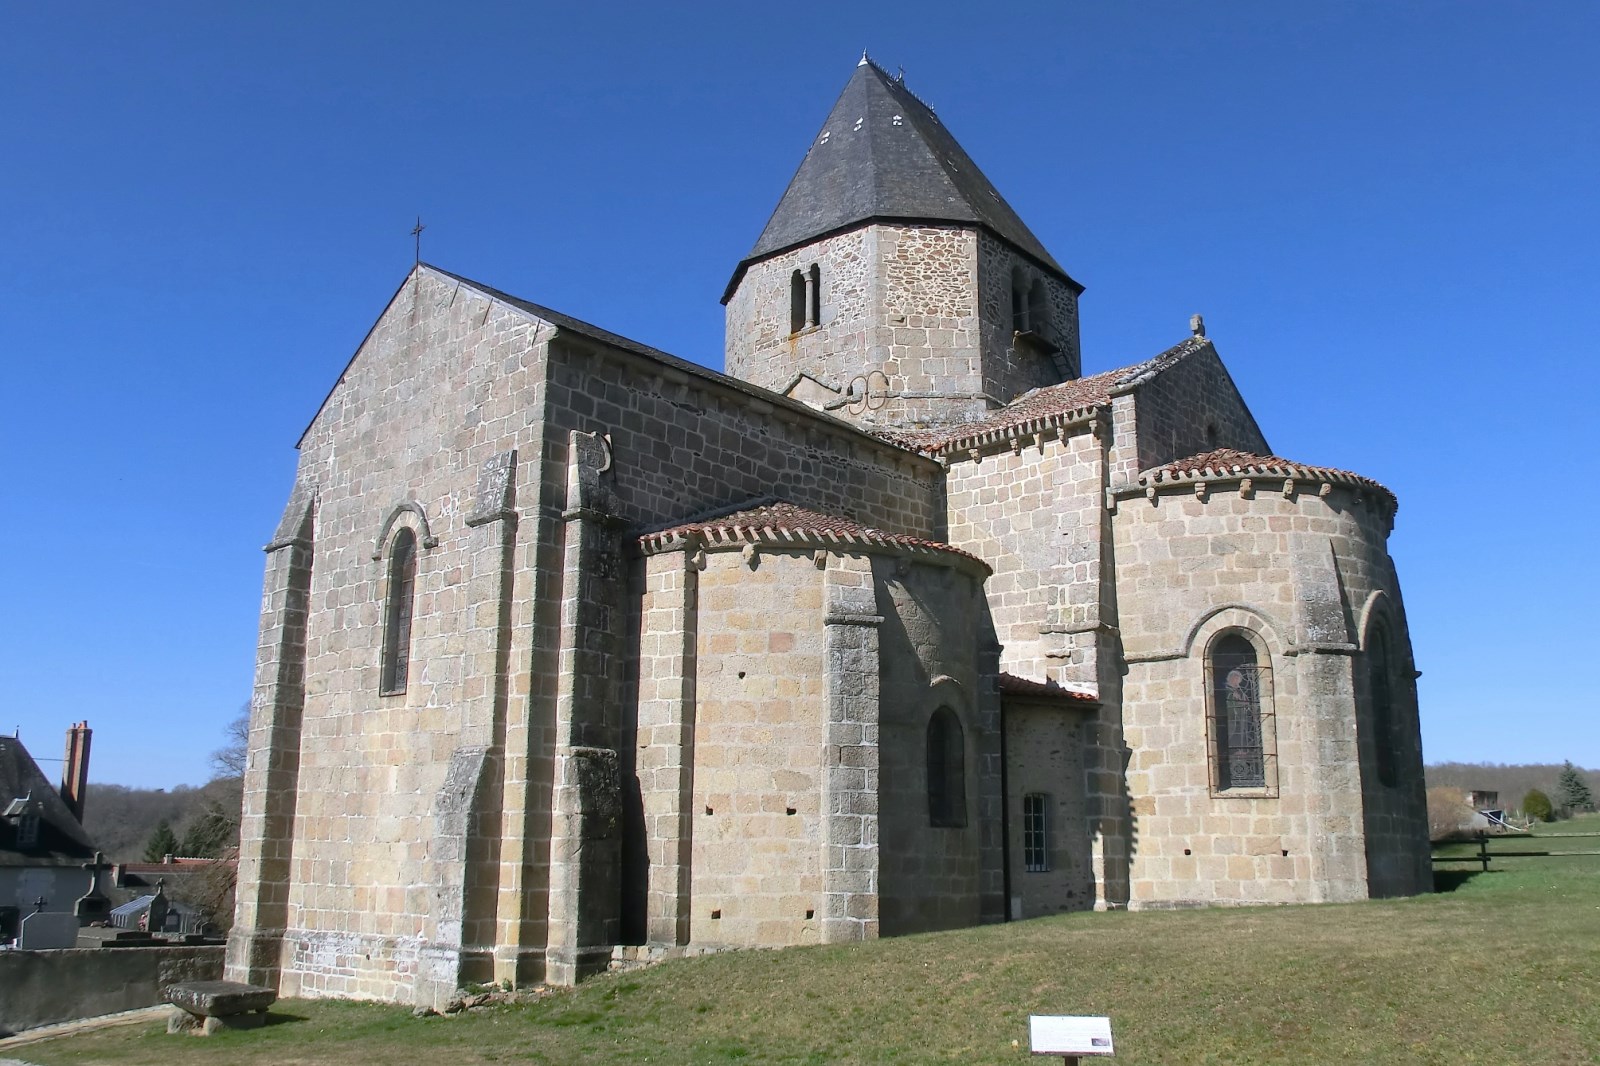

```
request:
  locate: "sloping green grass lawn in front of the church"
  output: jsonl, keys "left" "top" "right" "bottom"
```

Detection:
{"left": 21, "top": 816, "right": 1600, "bottom": 1066}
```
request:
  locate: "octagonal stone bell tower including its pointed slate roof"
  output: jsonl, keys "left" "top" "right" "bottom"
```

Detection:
{"left": 723, "top": 56, "right": 1083, "bottom": 429}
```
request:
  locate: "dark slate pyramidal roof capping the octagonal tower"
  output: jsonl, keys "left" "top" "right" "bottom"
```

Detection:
{"left": 723, "top": 56, "right": 1082, "bottom": 303}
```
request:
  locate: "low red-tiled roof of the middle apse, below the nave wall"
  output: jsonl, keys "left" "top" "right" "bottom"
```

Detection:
{"left": 638, "top": 498, "right": 989, "bottom": 570}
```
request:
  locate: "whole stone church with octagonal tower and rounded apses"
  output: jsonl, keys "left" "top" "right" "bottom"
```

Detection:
{"left": 229, "top": 58, "right": 1430, "bottom": 1004}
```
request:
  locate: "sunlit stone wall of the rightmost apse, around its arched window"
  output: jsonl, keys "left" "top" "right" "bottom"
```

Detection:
{"left": 1115, "top": 483, "right": 1414, "bottom": 906}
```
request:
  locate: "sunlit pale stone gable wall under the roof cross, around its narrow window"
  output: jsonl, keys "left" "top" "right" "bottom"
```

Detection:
{"left": 272, "top": 269, "right": 544, "bottom": 1000}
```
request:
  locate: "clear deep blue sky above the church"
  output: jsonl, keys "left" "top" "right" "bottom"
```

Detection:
{"left": 0, "top": 0, "right": 1600, "bottom": 786}
